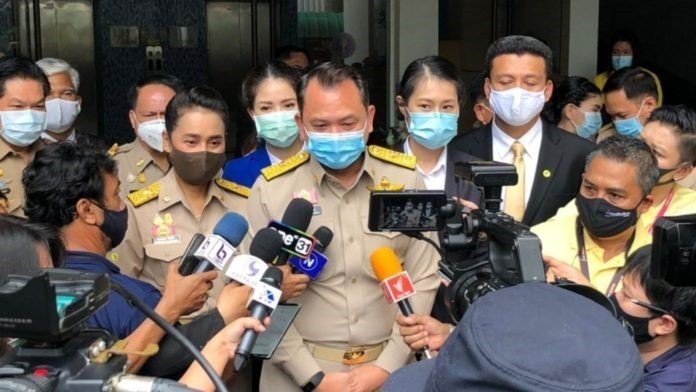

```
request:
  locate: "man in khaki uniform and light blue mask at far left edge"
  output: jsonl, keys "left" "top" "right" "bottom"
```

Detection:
{"left": 0, "top": 58, "right": 51, "bottom": 216}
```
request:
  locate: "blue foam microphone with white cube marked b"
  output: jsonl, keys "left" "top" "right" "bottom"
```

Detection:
{"left": 193, "top": 212, "right": 249, "bottom": 273}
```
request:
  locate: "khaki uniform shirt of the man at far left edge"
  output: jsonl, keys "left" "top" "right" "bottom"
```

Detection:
{"left": 0, "top": 138, "right": 44, "bottom": 217}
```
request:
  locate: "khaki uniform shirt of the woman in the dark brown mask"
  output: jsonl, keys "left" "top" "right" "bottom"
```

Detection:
{"left": 107, "top": 170, "right": 247, "bottom": 318}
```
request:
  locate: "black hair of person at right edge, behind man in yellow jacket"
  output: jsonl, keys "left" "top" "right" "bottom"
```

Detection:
{"left": 647, "top": 105, "right": 696, "bottom": 165}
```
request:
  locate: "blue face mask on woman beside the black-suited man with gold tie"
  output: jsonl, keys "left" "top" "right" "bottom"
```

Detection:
{"left": 407, "top": 112, "right": 459, "bottom": 150}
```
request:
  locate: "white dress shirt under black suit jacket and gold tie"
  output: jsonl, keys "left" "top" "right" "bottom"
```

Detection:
{"left": 491, "top": 119, "right": 542, "bottom": 210}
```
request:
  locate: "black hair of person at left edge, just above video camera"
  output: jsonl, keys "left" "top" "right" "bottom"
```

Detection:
{"left": 0, "top": 215, "right": 65, "bottom": 283}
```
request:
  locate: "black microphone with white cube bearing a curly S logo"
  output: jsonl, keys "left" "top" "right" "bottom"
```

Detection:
{"left": 225, "top": 227, "right": 283, "bottom": 287}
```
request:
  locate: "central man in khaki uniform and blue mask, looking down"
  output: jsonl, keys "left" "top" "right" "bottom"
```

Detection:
{"left": 248, "top": 63, "right": 439, "bottom": 391}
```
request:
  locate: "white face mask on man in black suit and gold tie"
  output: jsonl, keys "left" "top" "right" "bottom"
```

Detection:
{"left": 488, "top": 87, "right": 546, "bottom": 126}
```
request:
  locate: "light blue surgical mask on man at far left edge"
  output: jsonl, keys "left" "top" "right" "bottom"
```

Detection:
{"left": 0, "top": 110, "right": 46, "bottom": 147}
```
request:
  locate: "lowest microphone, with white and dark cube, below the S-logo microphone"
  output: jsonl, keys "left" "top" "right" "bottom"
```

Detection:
{"left": 234, "top": 266, "right": 283, "bottom": 371}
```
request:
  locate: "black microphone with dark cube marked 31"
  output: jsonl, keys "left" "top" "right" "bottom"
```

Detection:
{"left": 268, "top": 198, "right": 315, "bottom": 265}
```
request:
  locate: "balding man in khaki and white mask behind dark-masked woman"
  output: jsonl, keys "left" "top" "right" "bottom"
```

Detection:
{"left": 110, "top": 74, "right": 183, "bottom": 199}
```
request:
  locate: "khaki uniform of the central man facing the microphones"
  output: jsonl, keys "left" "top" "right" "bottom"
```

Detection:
{"left": 248, "top": 147, "right": 440, "bottom": 390}
